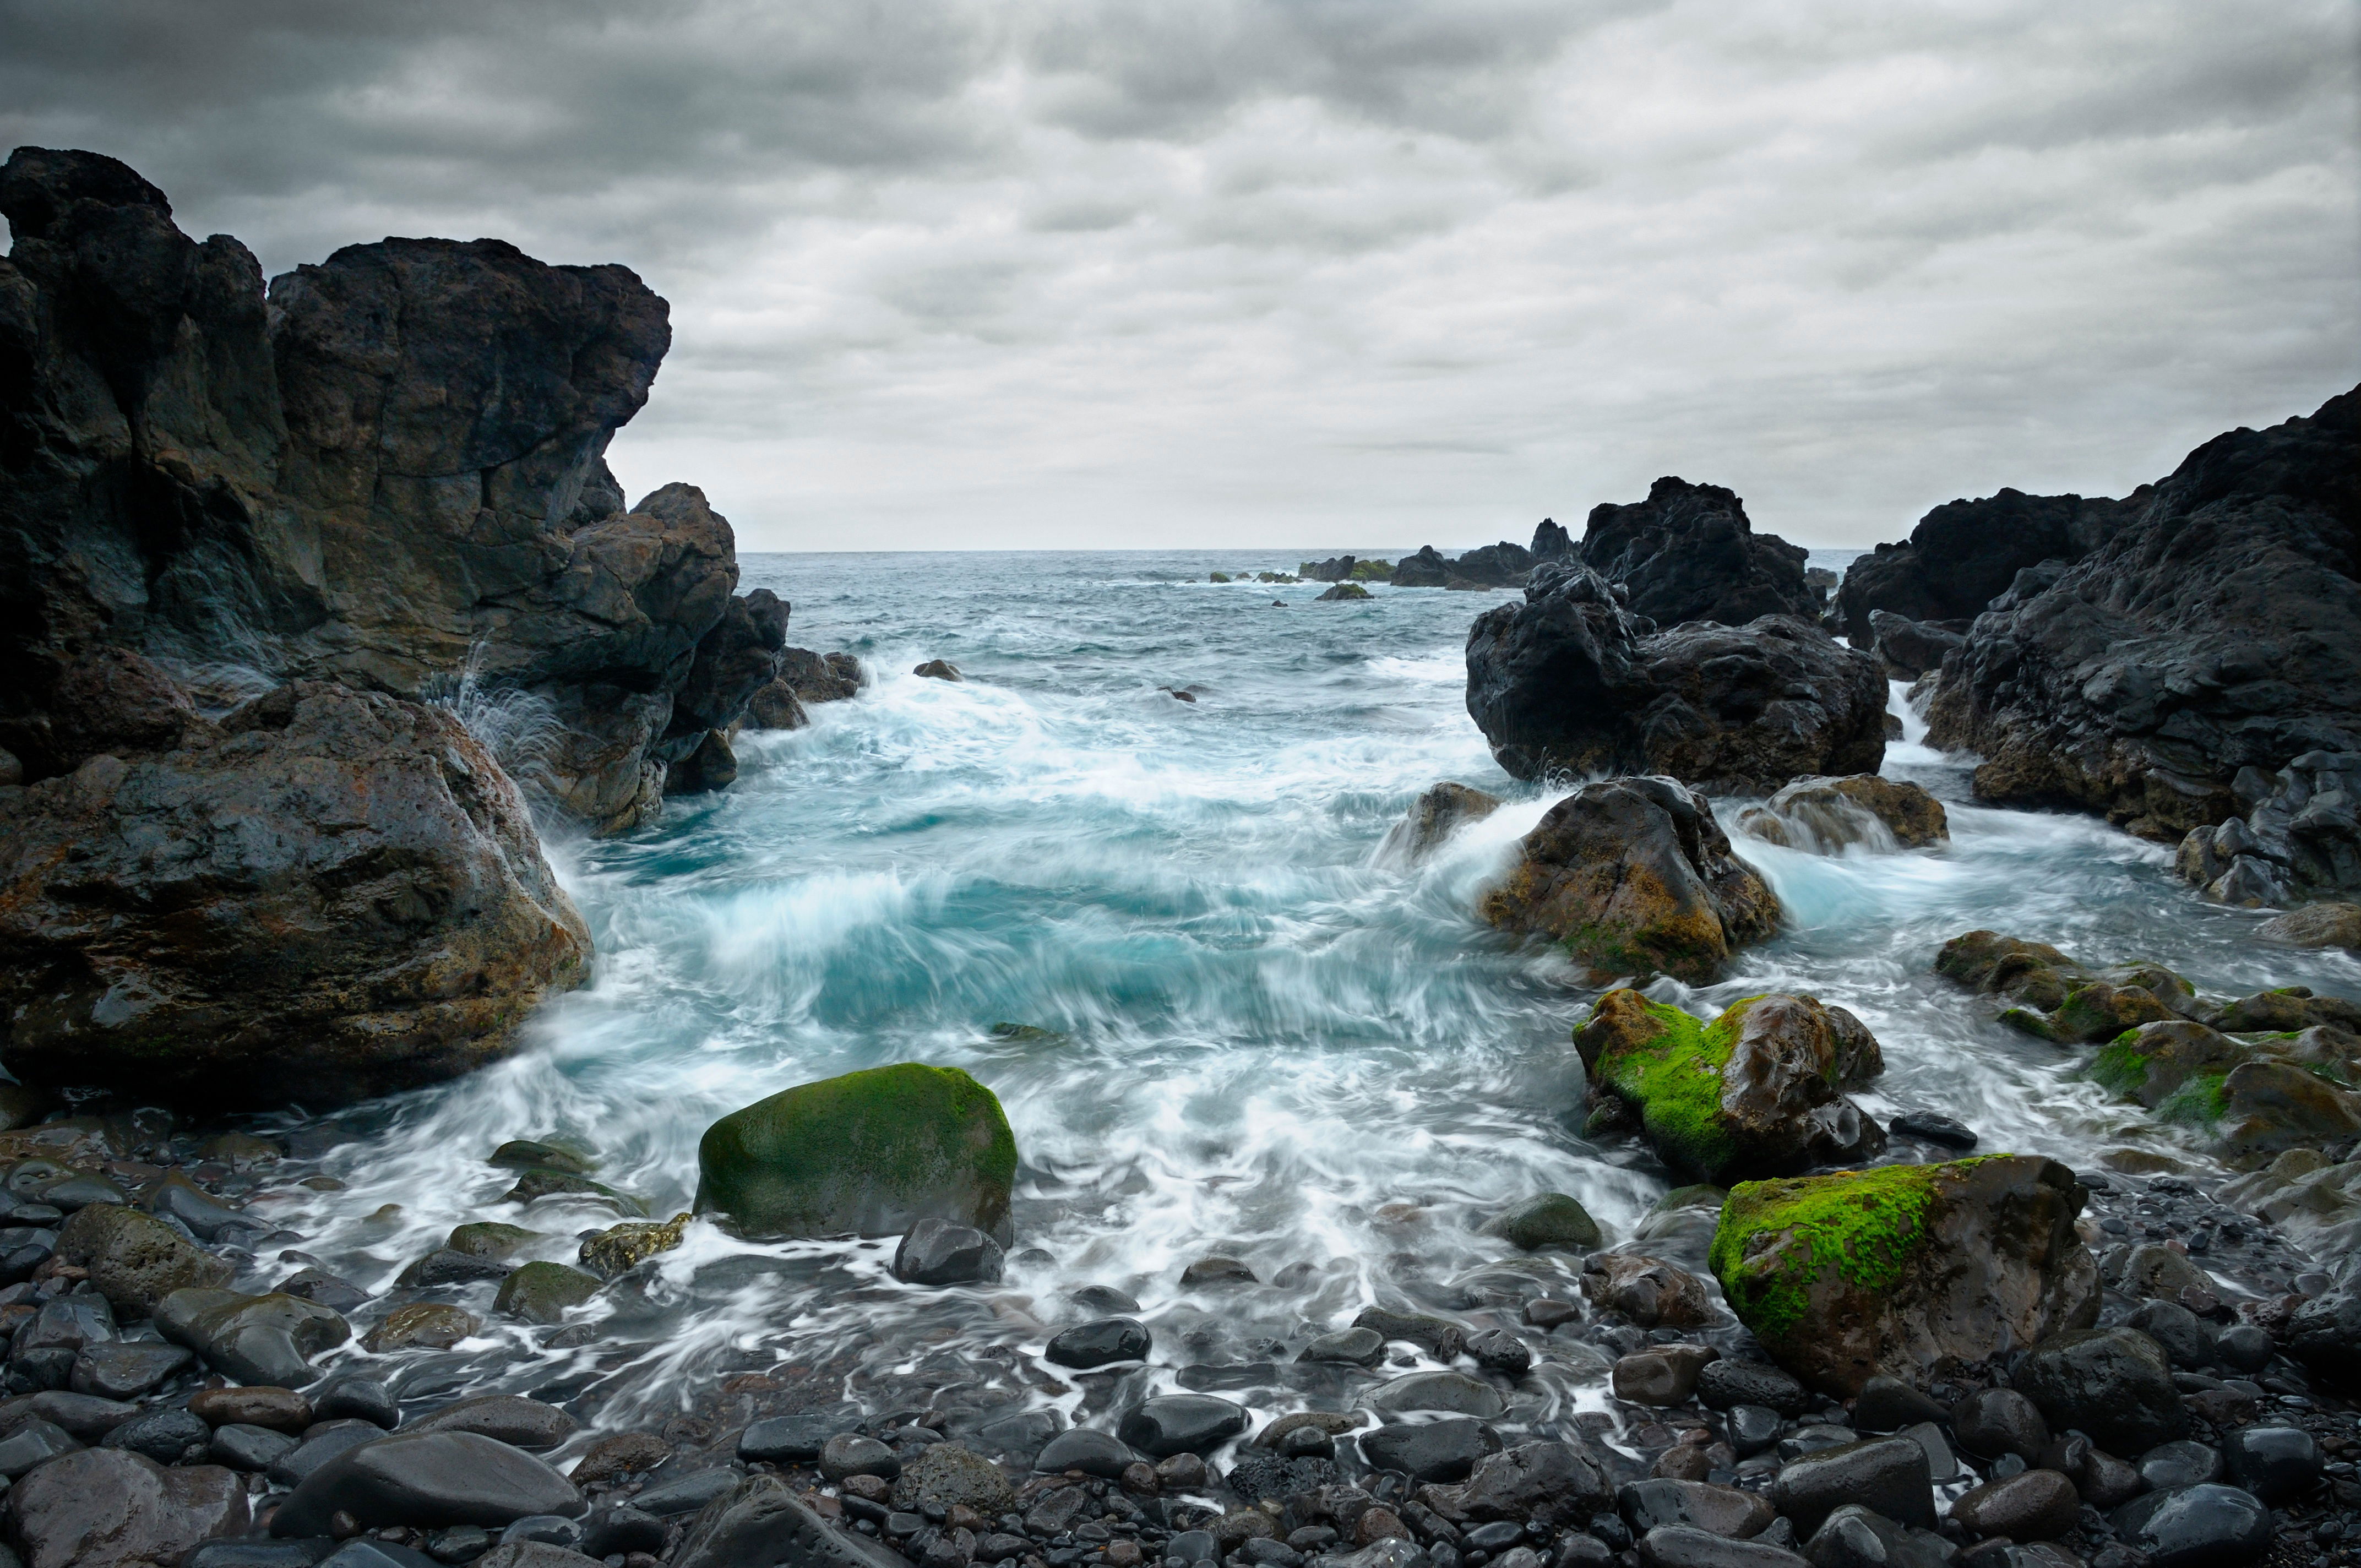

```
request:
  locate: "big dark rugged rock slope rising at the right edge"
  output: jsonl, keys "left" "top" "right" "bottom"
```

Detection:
{"left": 1929, "top": 390, "right": 2361, "bottom": 841}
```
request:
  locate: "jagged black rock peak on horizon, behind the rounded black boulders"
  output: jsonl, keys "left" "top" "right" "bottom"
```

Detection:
{"left": 1582, "top": 477, "right": 1820, "bottom": 626}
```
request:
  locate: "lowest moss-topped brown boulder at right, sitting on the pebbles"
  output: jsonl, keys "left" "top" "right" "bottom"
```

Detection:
{"left": 1712, "top": 1155, "right": 2099, "bottom": 1396}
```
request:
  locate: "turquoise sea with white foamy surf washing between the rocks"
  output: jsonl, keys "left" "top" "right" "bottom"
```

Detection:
{"left": 249, "top": 550, "right": 2361, "bottom": 1424}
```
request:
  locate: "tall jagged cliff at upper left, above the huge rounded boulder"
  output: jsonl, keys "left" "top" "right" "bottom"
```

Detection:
{"left": 0, "top": 149, "right": 786, "bottom": 831}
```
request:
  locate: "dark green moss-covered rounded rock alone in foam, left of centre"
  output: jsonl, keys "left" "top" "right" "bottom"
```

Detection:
{"left": 697, "top": 1063, "right": 1018, "bottom": 1247}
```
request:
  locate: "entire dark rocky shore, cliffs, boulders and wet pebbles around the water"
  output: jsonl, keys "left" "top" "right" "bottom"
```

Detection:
{"left": 0, "top": 137, "right": 2361, "bottom": 1568}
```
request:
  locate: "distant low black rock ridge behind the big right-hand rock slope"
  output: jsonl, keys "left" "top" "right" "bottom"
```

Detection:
{"left": 1837, "top": 487, "right": 2146, "bottom": 647}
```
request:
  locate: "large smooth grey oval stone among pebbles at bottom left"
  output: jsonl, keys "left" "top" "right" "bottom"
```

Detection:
{"left": 271, "top": 1431, "right": 585, "bottom": 1537}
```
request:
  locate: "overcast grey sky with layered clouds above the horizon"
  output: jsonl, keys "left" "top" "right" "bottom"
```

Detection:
{"left": 0, "top": 0, "right": 2361, "bottom": 550}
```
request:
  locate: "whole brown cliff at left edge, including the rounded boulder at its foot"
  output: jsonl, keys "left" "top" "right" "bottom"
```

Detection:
{"left": 0, "top": 149, "right": 788, "bottom": 1105}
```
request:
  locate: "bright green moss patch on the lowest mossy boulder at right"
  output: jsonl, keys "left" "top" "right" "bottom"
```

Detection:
{"left": 1707, "top": 1157, "right": 1983, "bottom": 1341}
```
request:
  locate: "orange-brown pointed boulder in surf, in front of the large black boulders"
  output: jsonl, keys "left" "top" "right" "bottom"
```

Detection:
{"left": 1478, "top": 777, "right": 1778, "bottom": 985}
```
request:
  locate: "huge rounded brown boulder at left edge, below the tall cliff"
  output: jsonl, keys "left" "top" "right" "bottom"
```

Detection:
{"left": 0, "top": 683, "right": 590, "bottom": 1105}
